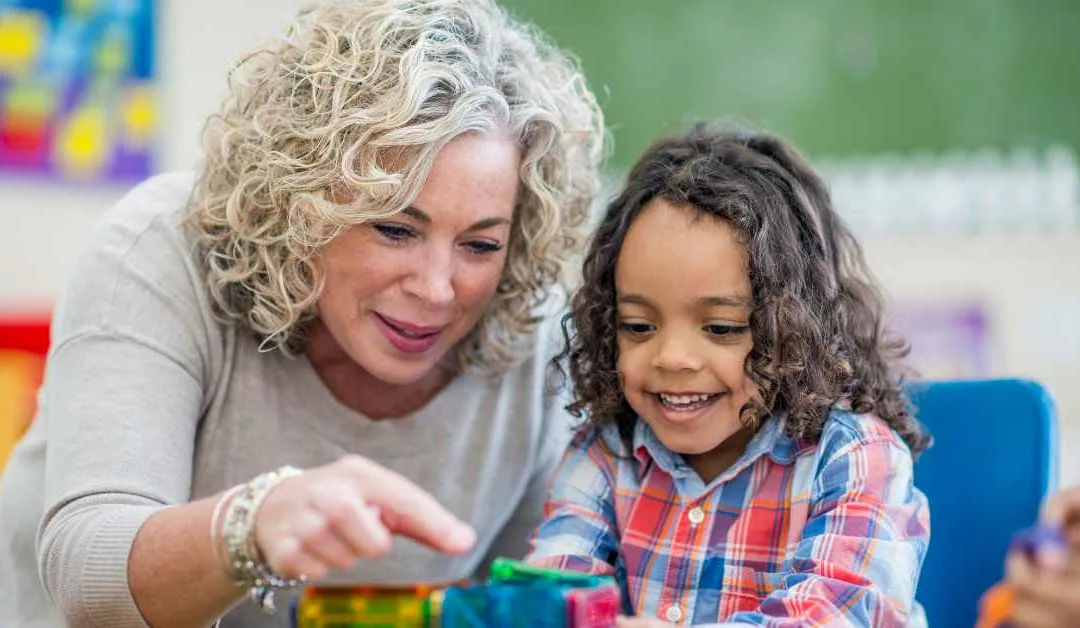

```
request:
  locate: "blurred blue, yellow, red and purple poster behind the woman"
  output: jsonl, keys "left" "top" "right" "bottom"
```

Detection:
{"left": 0, "top": 0, "right": 157, "bottom": 182}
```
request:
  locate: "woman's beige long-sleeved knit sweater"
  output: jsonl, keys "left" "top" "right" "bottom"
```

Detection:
{"left": 0, "top": 175, "right": 571, "bottom": 628}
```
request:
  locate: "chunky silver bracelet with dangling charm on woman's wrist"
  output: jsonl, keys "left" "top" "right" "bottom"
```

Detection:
{"left": 221, "top": 466, "right": 307, "bottom": 614}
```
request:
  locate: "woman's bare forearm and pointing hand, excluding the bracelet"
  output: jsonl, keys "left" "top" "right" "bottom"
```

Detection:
{"left": 130, "top": 456, "right": 475, "bottom": 626}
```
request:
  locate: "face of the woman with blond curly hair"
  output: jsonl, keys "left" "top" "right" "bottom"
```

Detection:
{"left": 319, "top": 134, "right": 521, "bottom": 385}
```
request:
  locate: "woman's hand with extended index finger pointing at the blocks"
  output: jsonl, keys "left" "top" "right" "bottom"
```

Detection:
{"left": 255, "top": 456, "right": 476, "bottom": 579}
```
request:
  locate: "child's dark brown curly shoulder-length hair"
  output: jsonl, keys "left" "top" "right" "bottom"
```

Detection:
{"left": 556, "top": 124, "right": 929, "bottom": 453}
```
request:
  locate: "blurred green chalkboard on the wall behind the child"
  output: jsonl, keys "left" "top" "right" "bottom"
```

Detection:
{"left": 502, "top": 0, "right": 1080, "bottom": 168}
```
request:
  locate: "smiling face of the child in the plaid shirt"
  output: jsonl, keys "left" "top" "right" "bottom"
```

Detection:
{"left": 616, "top": 199, "right": 756, "bottom": 481}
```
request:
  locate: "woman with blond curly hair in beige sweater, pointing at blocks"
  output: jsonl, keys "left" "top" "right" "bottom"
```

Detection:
{"left": 0, "top": 0, "right": 604, "bottom": 627}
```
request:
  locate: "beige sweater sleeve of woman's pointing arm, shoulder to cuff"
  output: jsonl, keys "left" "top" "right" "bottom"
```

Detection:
{"left": 37, "top": 176, "right": 221, "bottom": 626}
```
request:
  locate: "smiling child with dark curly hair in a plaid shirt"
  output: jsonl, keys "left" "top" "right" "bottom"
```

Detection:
{"left": 527, "top": 126, "right": 930, "bottom": 626}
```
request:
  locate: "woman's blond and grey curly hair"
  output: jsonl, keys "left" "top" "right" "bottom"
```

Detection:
{"left": 189, "top": 0, "right": 607, "bottom": 374}
